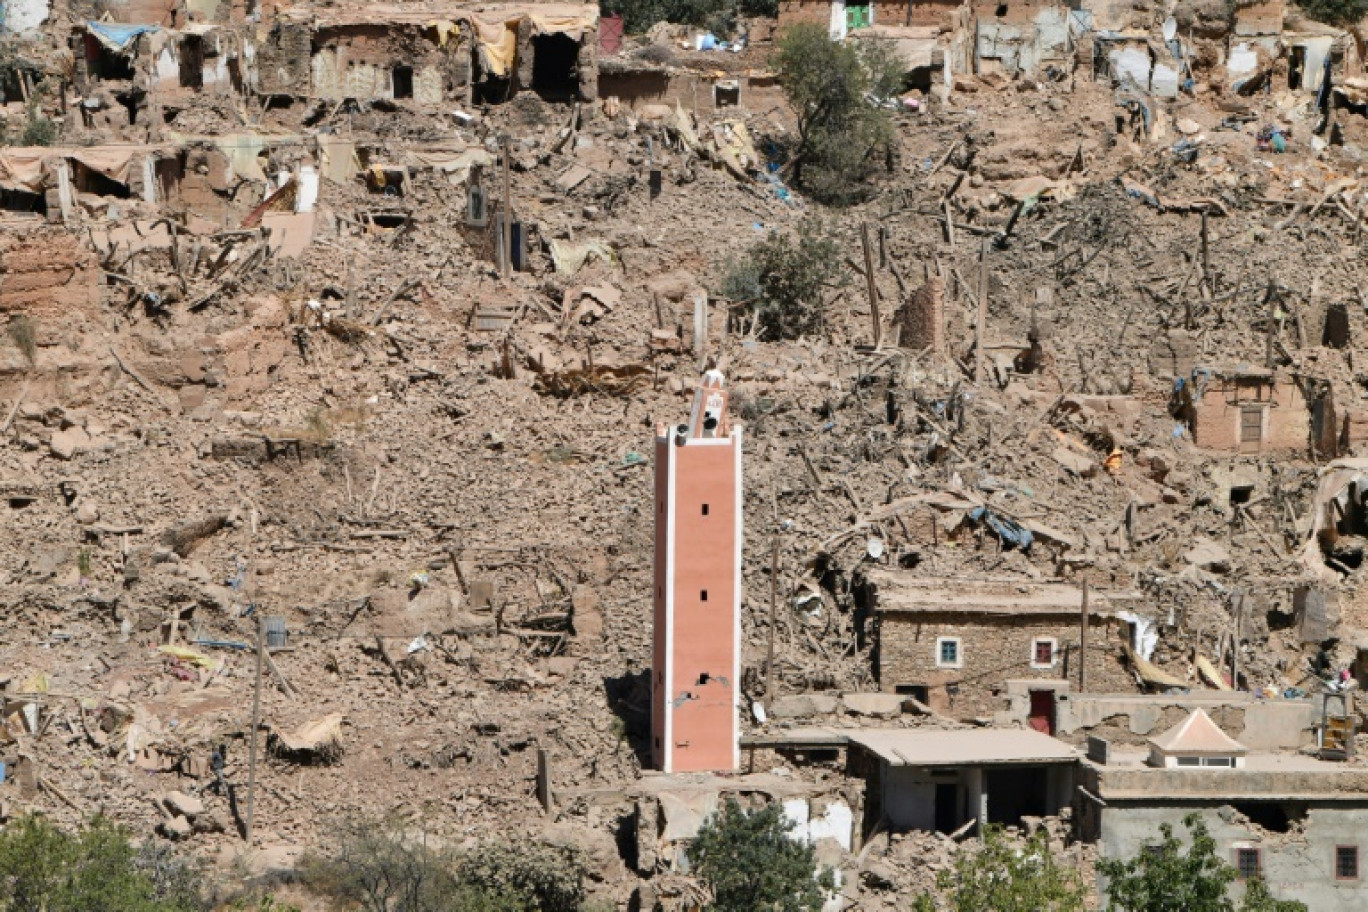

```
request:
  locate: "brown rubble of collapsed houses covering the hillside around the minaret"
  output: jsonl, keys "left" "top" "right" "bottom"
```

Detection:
{"left": 8, "top": 4, "right": 1368, "bottom": 908}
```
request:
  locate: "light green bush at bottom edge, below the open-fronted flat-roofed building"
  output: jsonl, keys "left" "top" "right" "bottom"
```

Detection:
{"left": 915, "top": 826, "right": 1083, "bottom": 912}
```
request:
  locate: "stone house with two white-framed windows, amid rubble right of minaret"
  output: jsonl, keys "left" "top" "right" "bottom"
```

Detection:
{"left": 860, "top": 570, "right": 1140, "bottom": 730}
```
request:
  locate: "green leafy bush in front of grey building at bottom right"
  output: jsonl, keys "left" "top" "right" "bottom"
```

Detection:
{"left": 1097, "top": 814, "right": 1306, "bottom": 912}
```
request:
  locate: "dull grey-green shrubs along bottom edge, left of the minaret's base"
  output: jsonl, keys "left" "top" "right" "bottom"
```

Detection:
{"left": 300, "top": 822, "right": 584, "bottom": 912}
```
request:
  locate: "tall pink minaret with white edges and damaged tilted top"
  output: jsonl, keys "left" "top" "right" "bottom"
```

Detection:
{"left": 651, "top": 371, "right": 741, "bottom": 773}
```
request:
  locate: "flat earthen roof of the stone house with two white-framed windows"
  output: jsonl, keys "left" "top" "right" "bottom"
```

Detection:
{"left": 865, "top": 570, "right": 1141, "bottom": 617}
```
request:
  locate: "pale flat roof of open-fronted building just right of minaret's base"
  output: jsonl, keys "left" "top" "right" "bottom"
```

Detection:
{"left": 850, "top": 729, "right": 1079, "bottom": 767}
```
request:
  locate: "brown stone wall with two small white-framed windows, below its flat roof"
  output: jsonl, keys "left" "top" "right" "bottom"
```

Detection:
{"left": 878, "top": 611, "right": 1135, "bottom": 716}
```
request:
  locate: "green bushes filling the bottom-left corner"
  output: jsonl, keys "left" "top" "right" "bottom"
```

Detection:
{"left": 0, "top": 815, "right": 204, "bottom": 912}
